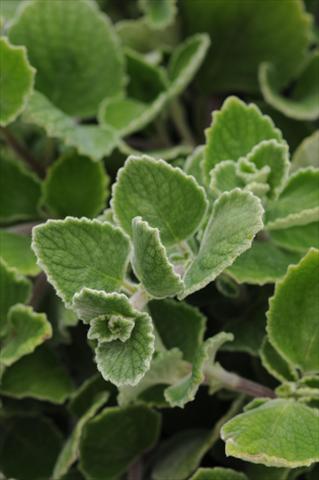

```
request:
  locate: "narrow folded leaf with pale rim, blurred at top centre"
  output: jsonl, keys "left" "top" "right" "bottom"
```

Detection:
{"left": 168, "top": 33, "right": 210, "bottom": 97}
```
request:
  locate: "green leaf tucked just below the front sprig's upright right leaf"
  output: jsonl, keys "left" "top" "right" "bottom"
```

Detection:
{"left": 227, "top": 240, "right": 300, "bottom": 285}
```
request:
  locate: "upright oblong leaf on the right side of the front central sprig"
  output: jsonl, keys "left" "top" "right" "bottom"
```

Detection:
{"left": 181, "top": 189, "right": 263, "bottom": 298}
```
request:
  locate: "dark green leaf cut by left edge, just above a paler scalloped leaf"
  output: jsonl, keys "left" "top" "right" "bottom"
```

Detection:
{"left": 0, "top": 258, "right": 31, "bottom": 336}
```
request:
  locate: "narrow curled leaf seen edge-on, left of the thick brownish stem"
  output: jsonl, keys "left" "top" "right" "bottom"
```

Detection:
{"left": 164, "top": 332, "right": 233, "bottom": 408}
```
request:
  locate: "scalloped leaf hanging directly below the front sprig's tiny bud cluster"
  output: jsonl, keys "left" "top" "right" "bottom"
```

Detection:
{"left": 95, "top": 312, "right": 155, "bottom": 387}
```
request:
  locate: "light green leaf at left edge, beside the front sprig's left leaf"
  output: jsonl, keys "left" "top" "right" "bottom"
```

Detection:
{"left": 0, "top": 230, "right": 40, "bottom": 275}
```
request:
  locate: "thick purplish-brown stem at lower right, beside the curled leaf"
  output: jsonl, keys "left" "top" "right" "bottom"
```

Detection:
{"left": 206, "top": 363, "right": 276, "bottom": 398}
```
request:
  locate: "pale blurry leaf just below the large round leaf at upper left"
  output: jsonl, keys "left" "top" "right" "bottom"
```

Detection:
{"left": 23, "top": 91, "right": 118, "bottom": 160}
